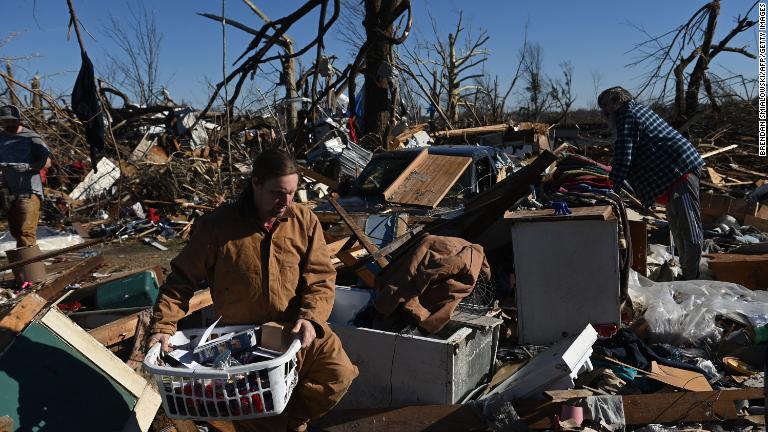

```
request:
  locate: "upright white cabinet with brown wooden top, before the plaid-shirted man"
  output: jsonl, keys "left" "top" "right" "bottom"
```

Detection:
{"left": 504, "top": 206, "right": 621, "bottom": 345}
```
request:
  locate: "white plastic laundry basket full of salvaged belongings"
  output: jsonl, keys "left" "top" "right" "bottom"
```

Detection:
{"left": 144, "top": 326, "right": 301, "bottom": 420}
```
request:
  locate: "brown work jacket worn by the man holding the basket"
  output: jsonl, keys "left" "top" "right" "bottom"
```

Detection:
{"left": 152, "top": 194, "right": 336, "bottom": 336}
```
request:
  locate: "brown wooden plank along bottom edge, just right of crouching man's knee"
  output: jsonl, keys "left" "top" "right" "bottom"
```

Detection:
{"left": 312, "top": 405, "right": 488, "bottom": 432}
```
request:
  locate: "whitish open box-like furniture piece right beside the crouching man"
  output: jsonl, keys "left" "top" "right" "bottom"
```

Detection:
{"left": 329, "top": 289, "right": 502, "bottom": 409}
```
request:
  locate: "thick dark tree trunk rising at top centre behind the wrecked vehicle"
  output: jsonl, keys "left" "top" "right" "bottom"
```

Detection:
{"left": 364, "top": 0, "right": 400, "bottom": 144}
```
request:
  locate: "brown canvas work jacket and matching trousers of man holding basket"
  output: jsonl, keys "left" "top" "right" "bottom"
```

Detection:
{"left": 152, "top": 197, "right": 358, "bottom": 431}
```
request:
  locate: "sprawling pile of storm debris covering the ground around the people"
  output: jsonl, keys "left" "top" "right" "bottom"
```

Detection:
{"left": 0, "top": 92, "right": 768, "bottom": 431}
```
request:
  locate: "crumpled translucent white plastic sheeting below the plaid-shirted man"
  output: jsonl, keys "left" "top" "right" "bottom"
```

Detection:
{"left": 629, "top": 271, "right": 768, "bottom": 346}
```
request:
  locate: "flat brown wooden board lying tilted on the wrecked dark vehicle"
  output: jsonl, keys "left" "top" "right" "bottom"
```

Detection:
{"left": 384, "top": 150, "right": 472, "bottom": 208}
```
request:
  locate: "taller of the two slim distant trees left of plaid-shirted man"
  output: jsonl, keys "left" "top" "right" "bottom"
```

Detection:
{"left": 520, "top": 42, "right": 552, "bottom": 122}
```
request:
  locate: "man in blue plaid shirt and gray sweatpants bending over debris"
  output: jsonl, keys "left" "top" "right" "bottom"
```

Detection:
{"left": 597, "top": 87, "right": 704, "bottom": 280}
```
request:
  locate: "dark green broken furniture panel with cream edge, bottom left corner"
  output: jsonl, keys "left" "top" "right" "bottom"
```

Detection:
{"left": 0, "top": 293, "right": 160, "bottom": 431}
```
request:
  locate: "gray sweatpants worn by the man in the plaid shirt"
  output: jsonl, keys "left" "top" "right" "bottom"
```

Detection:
{"left": 667, "top": 172, "right": 704, "bottom": 280}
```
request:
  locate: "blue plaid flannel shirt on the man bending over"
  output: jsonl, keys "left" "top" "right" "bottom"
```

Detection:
{"left": 610, "top": 101, "right": 704, "bottom": 206}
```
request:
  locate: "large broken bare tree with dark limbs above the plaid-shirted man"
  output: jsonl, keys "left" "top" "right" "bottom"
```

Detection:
{"left": 629, "top": 0, "right": 758, "bottom": 123}
